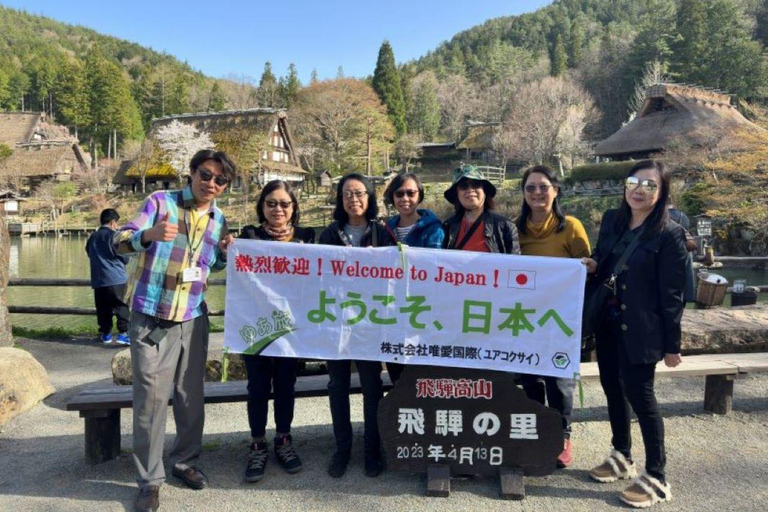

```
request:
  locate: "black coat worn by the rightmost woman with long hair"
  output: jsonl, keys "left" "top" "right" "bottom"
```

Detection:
{"left": 592, "top": 210, "right": 688, "bottom": 364}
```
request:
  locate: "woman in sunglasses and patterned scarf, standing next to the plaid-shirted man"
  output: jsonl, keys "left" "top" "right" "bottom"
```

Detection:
{"left": 240, "top": 180, "right": 315, "bottom": 482}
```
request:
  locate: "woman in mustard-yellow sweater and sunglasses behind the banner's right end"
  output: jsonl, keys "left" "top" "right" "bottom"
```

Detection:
{"left": 515, "top": 165, "right": 590, "bottom": 468}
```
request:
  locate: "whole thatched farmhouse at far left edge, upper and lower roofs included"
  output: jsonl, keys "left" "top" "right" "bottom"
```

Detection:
{"left": 0, "top": 112, "right": 90, "bottom": 193}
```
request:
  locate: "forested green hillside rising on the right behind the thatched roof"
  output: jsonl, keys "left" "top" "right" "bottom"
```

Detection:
{"left": 408, "top": 0, "right": 768, "bottom": 138}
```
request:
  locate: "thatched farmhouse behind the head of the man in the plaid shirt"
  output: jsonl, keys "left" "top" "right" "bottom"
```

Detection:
{"left": 113, "top": 108, "right": 309, "bottom": 192}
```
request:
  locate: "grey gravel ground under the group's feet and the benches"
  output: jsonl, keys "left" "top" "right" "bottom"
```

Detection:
{"left": 0, "top": 335, "right": 768, "bottom": 512}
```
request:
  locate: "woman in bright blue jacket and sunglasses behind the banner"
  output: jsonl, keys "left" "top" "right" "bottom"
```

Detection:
{"left": 384, "top": 172, "right": 445, "bottom": 384}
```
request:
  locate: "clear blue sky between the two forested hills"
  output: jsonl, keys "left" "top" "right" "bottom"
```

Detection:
{"left": 0, "top": 0, "right": 551, "bottom": 83}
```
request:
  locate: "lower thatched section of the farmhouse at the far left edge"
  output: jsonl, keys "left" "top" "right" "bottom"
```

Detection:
{"left": 0, "top": 141, "right": 88, "bottom": 188}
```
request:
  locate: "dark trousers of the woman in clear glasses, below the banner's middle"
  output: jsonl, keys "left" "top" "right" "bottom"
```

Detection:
{"left": 328, "top": 359, "right": 383, "bottom": 457}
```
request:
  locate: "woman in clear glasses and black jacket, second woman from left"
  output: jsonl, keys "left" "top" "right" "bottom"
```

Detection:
{"left": 319, "top": 173, "right": 395, "bottom": 478}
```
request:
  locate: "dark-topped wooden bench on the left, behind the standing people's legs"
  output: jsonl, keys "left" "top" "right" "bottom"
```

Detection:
{"left": 67, "top": 372, "right": 392, "bottom": 464}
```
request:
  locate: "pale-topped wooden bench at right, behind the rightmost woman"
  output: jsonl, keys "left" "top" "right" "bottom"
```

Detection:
{"left": 581, "top": 352, "right": 768, "bottom": 414}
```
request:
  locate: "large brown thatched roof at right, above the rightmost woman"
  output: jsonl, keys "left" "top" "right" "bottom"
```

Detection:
{"left": 595, "top": 84, "right": 765, "bottom": 160}
